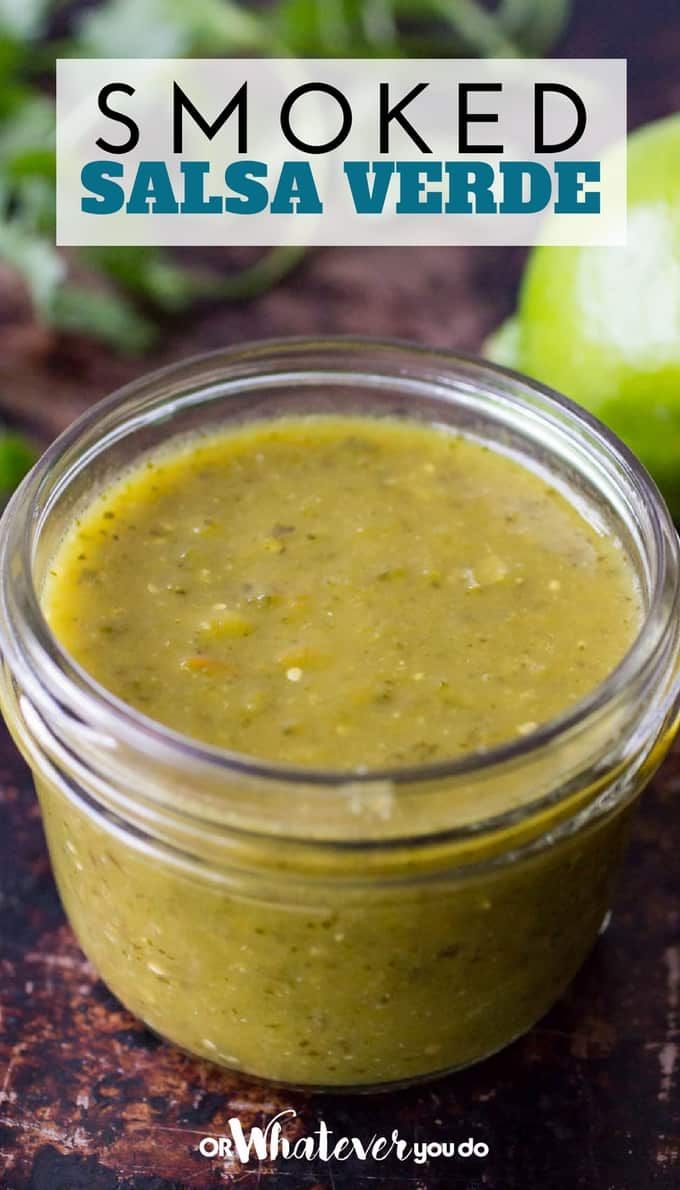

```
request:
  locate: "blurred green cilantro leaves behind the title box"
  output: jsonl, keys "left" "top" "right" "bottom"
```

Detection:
{"left": 0, "top": 0, "right": 570, "bottom": 353}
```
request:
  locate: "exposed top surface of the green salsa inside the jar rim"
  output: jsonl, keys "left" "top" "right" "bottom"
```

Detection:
{"left": 44, "top": 417, "right": 641, "bottom": 769}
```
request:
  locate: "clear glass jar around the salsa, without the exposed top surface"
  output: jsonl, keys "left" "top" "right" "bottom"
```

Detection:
{"left": 0, "top": 339, "right": 680, "bottom": 1090}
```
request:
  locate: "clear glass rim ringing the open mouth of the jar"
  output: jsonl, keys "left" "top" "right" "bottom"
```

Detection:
{"left": 0, "top": 336, "right": 680, "bottom": 799}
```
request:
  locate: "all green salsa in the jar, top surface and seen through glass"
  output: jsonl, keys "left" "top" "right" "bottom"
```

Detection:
{"left": 38, "top": 415, "right": 642, "bottom": 1088}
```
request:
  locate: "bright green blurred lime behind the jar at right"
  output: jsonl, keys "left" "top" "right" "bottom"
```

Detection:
{"left": 487, "top": 113, "right": 680, "bottom": 518}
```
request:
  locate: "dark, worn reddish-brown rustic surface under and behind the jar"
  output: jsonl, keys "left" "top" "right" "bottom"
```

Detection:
{"left": 0, "top": 0, "right": 680, "bottom": 1190}
